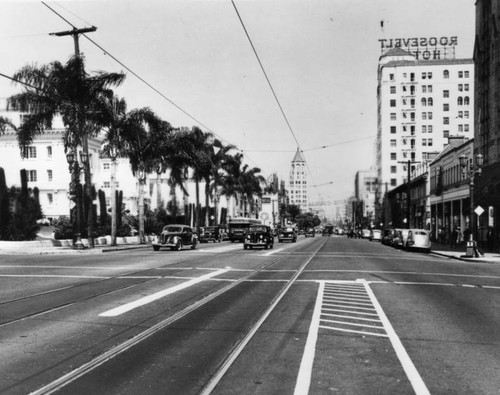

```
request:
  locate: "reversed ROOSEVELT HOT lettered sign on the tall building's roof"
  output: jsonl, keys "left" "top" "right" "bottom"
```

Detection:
{"left": 378, "top": 36, "right": 458, "bottom": 60}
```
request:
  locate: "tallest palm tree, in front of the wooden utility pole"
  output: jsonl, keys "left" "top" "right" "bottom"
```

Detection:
{"left": 9, "top": 56, "right": 125, "bottom": 247}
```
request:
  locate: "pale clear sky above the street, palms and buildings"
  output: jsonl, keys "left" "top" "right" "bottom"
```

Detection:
{"left": 0, "top": 0, "right": 475, "bottom": 201}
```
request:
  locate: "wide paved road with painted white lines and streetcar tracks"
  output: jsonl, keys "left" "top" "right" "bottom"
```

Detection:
{"left": 0, "top": 237, "right": 500, "bottom": 394}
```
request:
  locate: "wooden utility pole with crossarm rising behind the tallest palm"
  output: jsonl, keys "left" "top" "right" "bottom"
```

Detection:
{"left": 49, "top": 24, "right": 97, "bottom": 248}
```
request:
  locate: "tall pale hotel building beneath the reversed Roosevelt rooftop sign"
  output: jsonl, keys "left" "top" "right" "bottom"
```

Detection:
{"left": 376, "top": 47, "right": 474, "bottom": 193}
